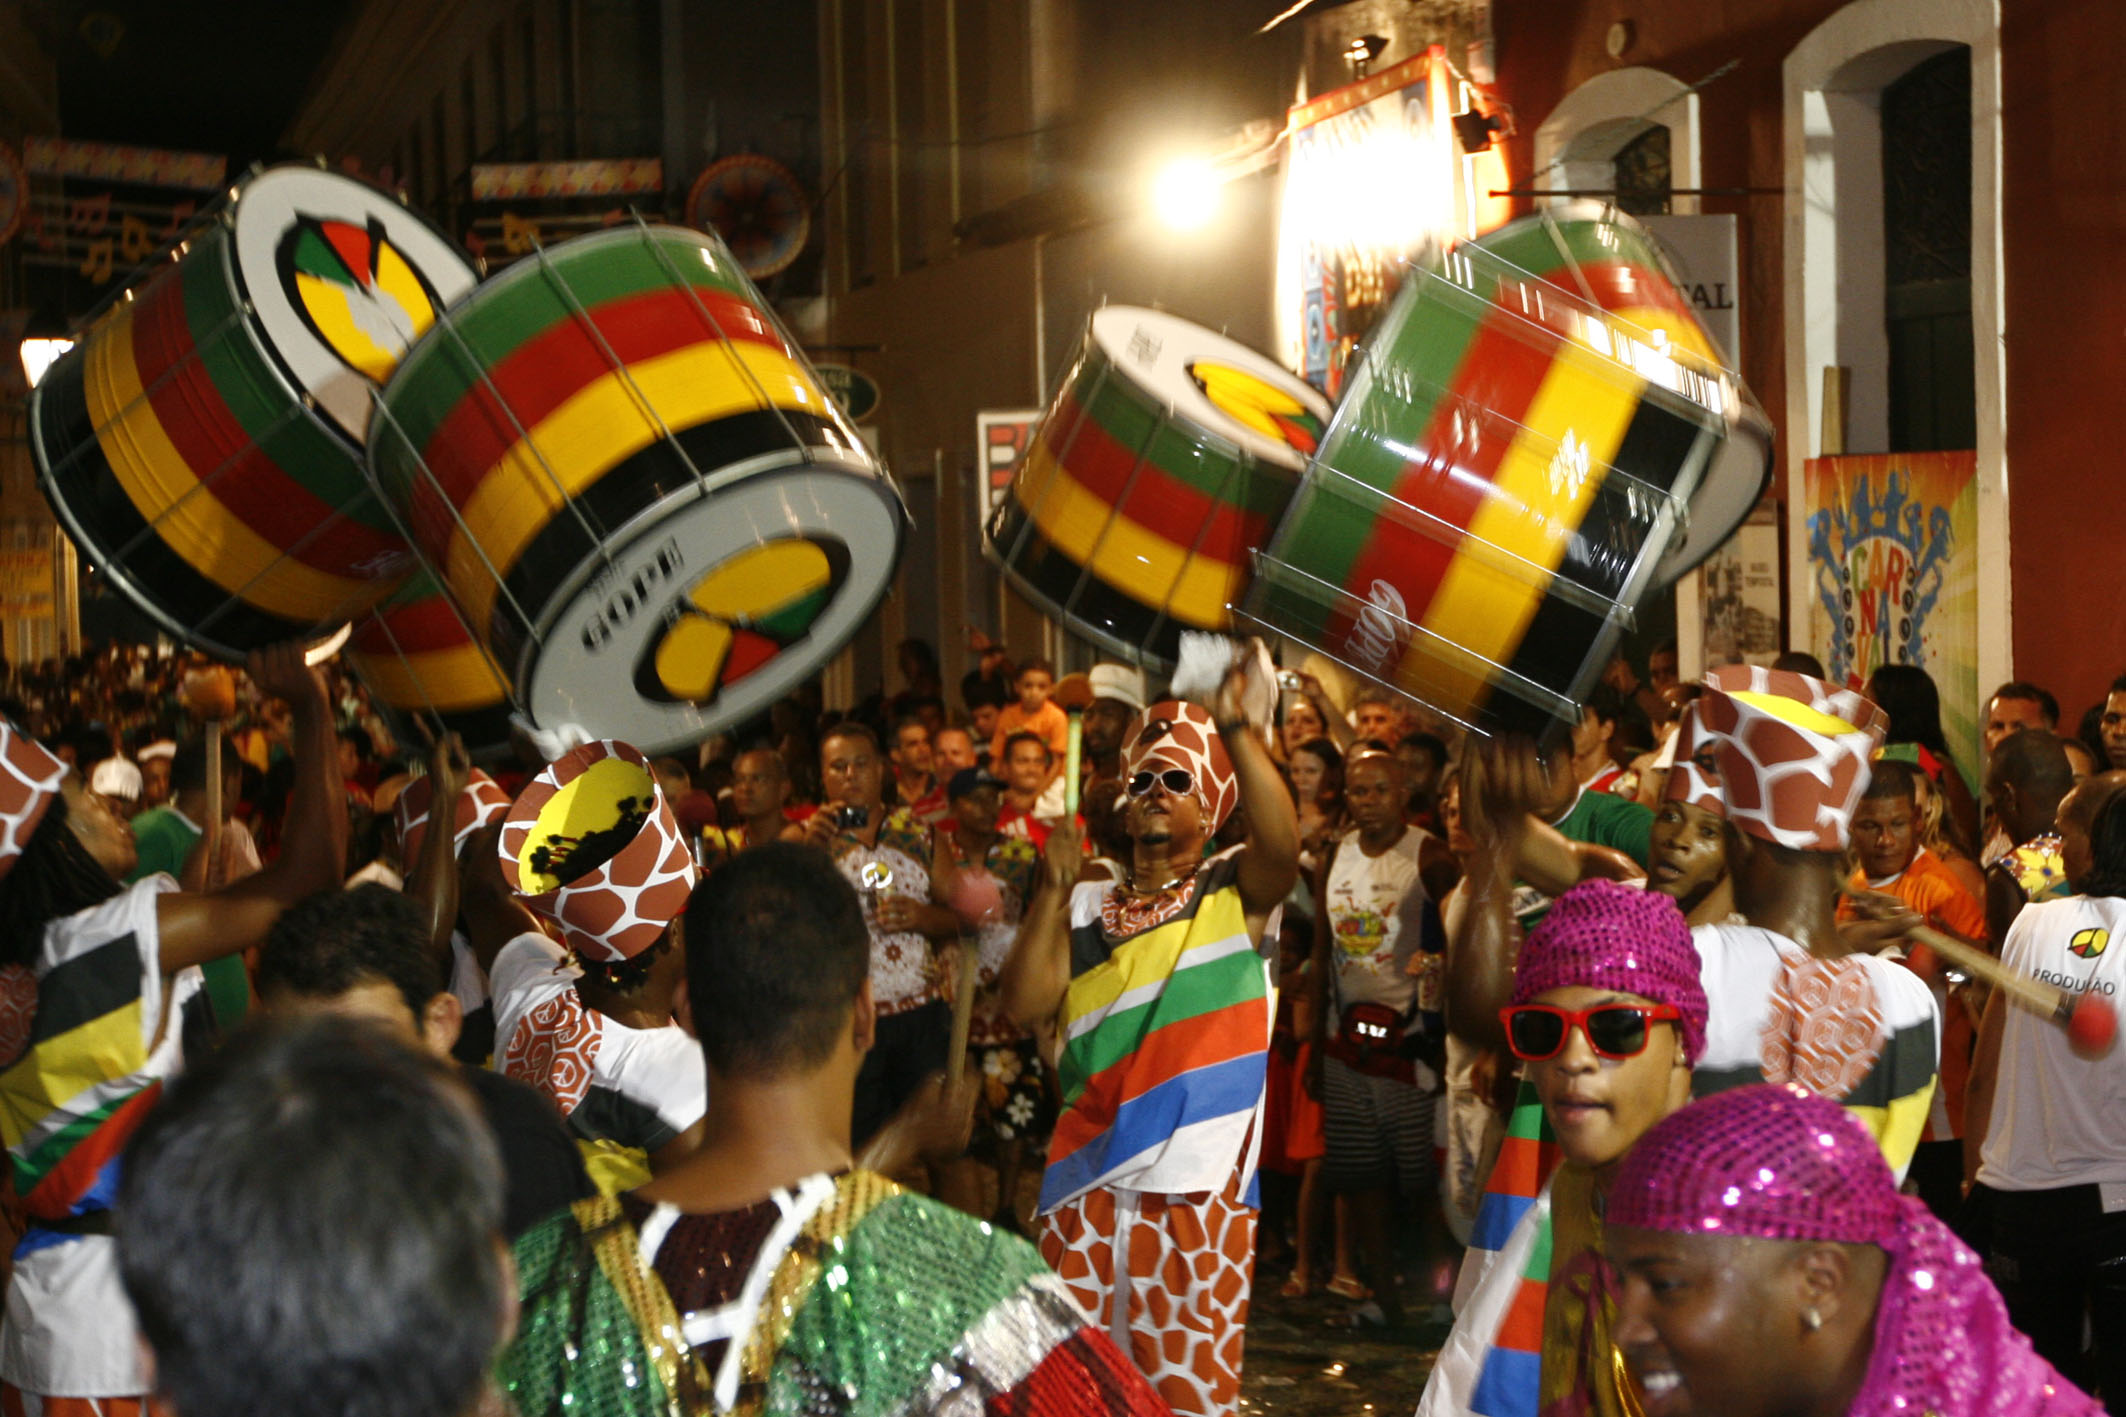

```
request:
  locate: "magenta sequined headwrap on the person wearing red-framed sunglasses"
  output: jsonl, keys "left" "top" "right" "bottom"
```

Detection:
{"left": 1514, "top": 880, "right": 1705, "bottom": 1064}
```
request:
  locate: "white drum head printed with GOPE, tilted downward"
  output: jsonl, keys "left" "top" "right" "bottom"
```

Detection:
{"left": 521, "top": 465, "right": 908, "bottom": 754}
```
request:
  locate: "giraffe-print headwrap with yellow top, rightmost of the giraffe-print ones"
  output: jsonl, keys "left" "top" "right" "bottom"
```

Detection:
{"left": 1669, "top": 665, "right": 1890, "bottom": 852}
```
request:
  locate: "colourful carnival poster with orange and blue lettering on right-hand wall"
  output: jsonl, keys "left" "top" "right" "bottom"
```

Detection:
{"left": 1803, "top": 453, "right": 1979, "bottom": 773}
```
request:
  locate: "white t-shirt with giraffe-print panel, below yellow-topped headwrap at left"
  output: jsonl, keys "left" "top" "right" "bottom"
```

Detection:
{"left": 487, "top": 933, "right": 708, "bottom": 1151}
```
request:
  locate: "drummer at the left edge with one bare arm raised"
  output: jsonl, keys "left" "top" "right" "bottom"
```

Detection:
{"left": 0, "top": 646, "right": 347, "bottom": 1413}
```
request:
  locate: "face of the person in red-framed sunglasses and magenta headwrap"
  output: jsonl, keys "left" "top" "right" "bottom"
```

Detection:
{"left": 1522, "top": 984, "right": 1690, "bottom": 1166}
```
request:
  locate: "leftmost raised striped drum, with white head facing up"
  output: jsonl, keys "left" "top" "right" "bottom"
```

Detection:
{"left": 30, "top": 168, "right": 474, "bottom": 659}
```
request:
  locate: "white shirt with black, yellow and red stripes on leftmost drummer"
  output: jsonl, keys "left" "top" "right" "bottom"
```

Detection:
{"left": 0, "top": 873, "right": 202, "bottom": 1398}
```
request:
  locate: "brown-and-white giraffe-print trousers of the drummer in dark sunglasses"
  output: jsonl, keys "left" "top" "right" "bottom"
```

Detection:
{"left": 1040, "top": 1168, "right": 1256, "bottom": 1417}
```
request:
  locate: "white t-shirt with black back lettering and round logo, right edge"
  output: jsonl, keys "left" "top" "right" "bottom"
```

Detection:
{"left": 1979, "top": 897, "right": 2126, "bottom": 1209}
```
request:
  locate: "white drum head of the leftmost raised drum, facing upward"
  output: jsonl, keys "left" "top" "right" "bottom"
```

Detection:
{"left": 234, "top": 166, "right": 478, "bottom": 444}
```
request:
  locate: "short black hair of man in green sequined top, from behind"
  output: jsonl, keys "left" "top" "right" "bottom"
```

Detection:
{"left": 687, "top": 841, "right": 872, "bottom": 1079}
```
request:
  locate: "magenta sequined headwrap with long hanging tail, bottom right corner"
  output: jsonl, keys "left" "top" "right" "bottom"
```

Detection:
{"left": 1607, "top": 1083, "right": 2103, "bottom": 1417}
